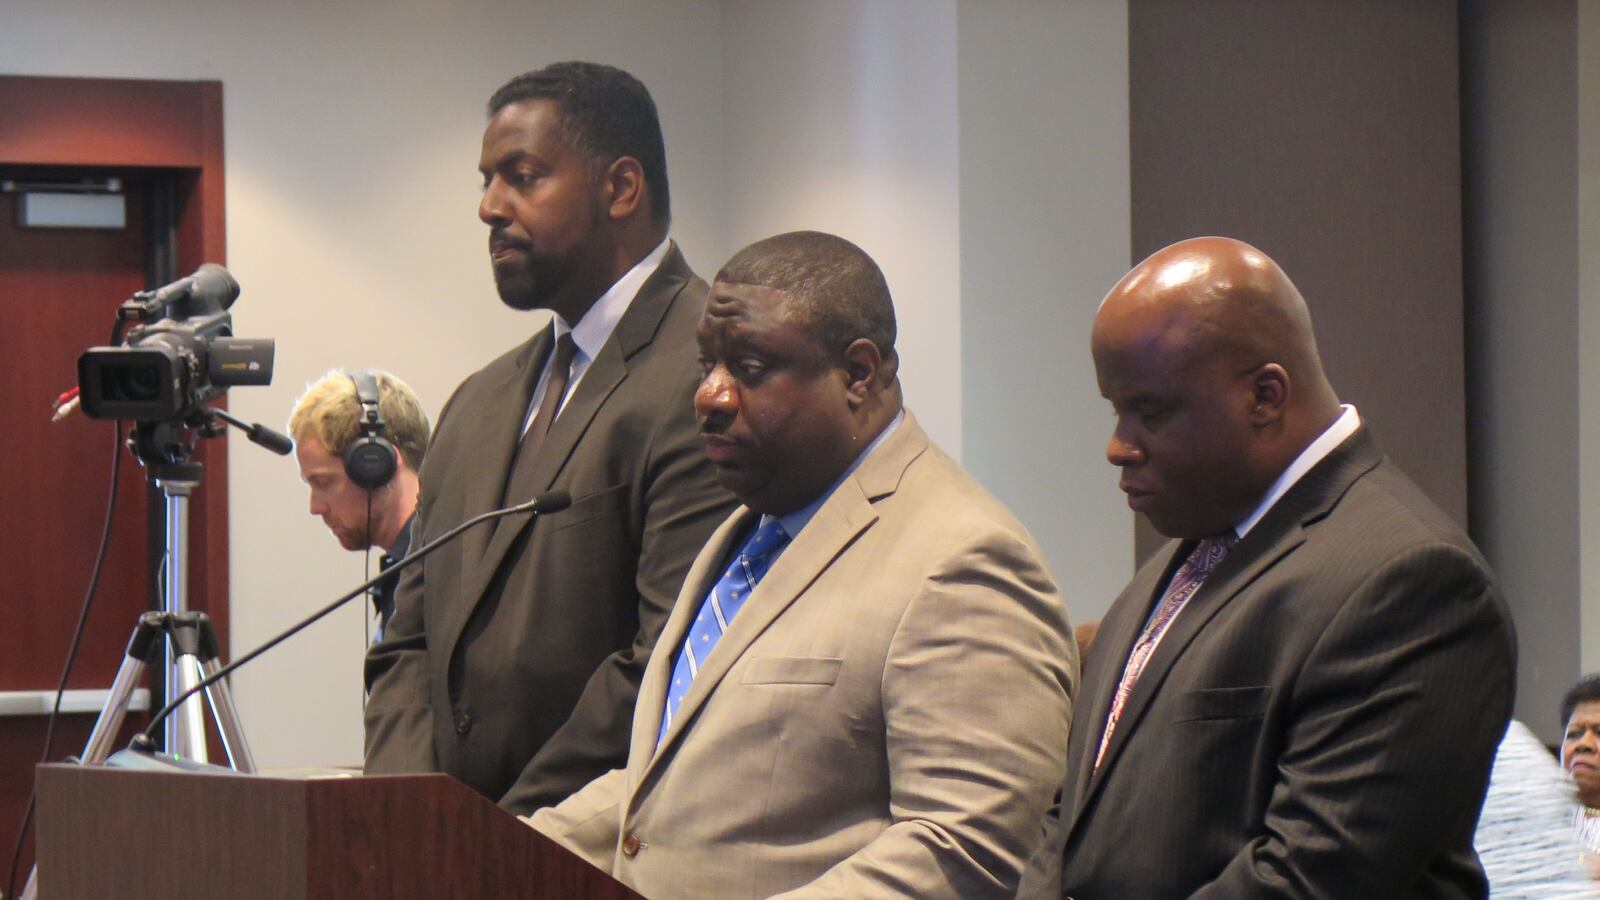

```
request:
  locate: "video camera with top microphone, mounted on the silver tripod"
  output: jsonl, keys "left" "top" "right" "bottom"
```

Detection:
{"left": 78, "top": 263, "right": 275, "bottom": 423}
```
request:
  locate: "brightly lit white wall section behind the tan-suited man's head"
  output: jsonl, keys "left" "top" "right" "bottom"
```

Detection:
{"left": 707, "top": 0, "right": 962, "bottom": 448}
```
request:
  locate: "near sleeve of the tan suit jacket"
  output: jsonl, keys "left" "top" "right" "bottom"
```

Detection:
{"left": 782, "top": 531, "right": 1077, "bottom": 900}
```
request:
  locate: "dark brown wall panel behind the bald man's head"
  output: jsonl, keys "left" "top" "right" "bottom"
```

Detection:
{"left": 1128, "top": 0, "right": 1466, "bottom": 552}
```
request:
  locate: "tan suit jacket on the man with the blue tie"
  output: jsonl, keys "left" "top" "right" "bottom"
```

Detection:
{"left": 533, "top": 413, "right": 1077, "bottom": 900}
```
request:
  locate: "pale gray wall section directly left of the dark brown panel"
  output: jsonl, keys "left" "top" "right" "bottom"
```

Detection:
{"left": 960, "top": 0, "right": 1133, "bottom": 623}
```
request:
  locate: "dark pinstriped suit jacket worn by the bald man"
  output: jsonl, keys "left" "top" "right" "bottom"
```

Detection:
{"left": 1024, "top": 428, "right": 1515, "bottom": 900}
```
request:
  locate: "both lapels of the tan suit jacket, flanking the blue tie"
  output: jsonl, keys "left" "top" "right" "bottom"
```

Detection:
{"left": 632, "top": 412, "right": 928, "bottom": 786}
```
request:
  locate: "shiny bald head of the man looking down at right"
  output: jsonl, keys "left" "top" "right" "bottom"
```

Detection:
{"left": 1093, "top": 237, "right": 1339, "bottom": 538}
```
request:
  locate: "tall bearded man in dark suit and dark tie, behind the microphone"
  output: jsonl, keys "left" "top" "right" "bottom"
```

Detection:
{"left": 366, "top": 62, "right": 733, "bottom": 814}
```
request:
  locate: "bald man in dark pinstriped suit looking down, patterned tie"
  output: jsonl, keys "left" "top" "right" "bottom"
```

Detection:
{"left": 1024, "top": 237, "right": 1515, "bottom": 900}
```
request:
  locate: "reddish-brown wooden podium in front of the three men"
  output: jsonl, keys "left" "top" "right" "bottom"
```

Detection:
{"left": 37, "top": 755, "right": 642, "bottom": 900}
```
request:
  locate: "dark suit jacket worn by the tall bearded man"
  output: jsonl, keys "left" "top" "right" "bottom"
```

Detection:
{"left": 366, "top": 247, "right": 734, "bottom": 814}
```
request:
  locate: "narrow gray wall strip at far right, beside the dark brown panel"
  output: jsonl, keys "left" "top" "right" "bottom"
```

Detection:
{"left": 1461, "top": 0, "right": 1594, "bottom": 741}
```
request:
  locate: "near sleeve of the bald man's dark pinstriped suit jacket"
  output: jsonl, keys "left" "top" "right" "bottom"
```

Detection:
{"left": 1195, "top": 543, "right": 1515, "bottom": 900}
